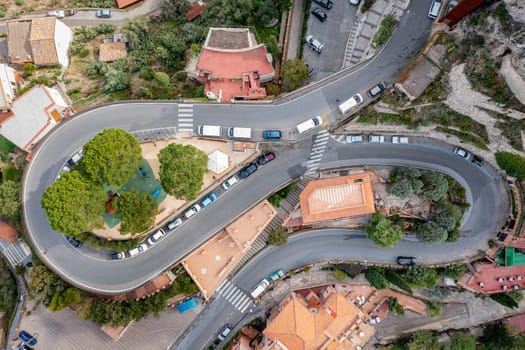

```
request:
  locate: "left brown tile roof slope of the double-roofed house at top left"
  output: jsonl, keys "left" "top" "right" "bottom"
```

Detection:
{"left": 7, "top": 19, "right": 32, "bottom": 63}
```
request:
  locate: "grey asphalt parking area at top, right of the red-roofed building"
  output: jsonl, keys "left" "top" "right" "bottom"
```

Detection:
{"left": 303, "top": 0, "right": 357, "bottom": 81}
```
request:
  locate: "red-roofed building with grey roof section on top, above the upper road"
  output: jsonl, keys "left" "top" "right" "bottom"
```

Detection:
{"left": 187, "top": 28, "right": 275, "bottom": 103}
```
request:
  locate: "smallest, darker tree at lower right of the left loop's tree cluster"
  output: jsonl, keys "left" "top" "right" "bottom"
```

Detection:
{"left": 117, "top": 191, "right": 158, "bottom": 234}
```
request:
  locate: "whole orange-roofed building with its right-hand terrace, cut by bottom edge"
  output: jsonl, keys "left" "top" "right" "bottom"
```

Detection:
{"left": 263, "top": 286, "right": 375, "bottom": 350}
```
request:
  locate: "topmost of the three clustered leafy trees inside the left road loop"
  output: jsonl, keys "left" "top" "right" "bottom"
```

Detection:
{"left": 80, "top": 129, "right": 142, "bottom": 185}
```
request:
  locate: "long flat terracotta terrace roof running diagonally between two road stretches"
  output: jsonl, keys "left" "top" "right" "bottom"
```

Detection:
{"left": 182, "top": 201, "right": 277, "bottom": 298}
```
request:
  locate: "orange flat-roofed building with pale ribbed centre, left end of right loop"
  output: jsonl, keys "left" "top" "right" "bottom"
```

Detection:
{"left": 299, "top": 173, "right": 375, "bottom": 224}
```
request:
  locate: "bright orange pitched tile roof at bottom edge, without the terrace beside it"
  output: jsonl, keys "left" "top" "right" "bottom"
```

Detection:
{"left": 263, "top": 287, "right": 360, "bottom": 350}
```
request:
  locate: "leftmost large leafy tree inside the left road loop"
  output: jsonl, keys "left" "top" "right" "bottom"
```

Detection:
{"left": 41, "top": 171, "right": 106, "bottom": 236}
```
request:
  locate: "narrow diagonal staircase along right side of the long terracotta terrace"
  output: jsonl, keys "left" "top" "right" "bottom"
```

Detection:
{"left": 230, "top": 178, "right": 308, "bottom": 277}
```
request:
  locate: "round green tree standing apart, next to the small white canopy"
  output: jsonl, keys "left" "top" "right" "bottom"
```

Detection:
{"left": 159, "top": 144, "right": 208, "bottom": 200}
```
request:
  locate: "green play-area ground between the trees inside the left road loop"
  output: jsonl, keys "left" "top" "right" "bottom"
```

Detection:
{"left": 104, "top": 159, "right": 167, "bottom": 227}
